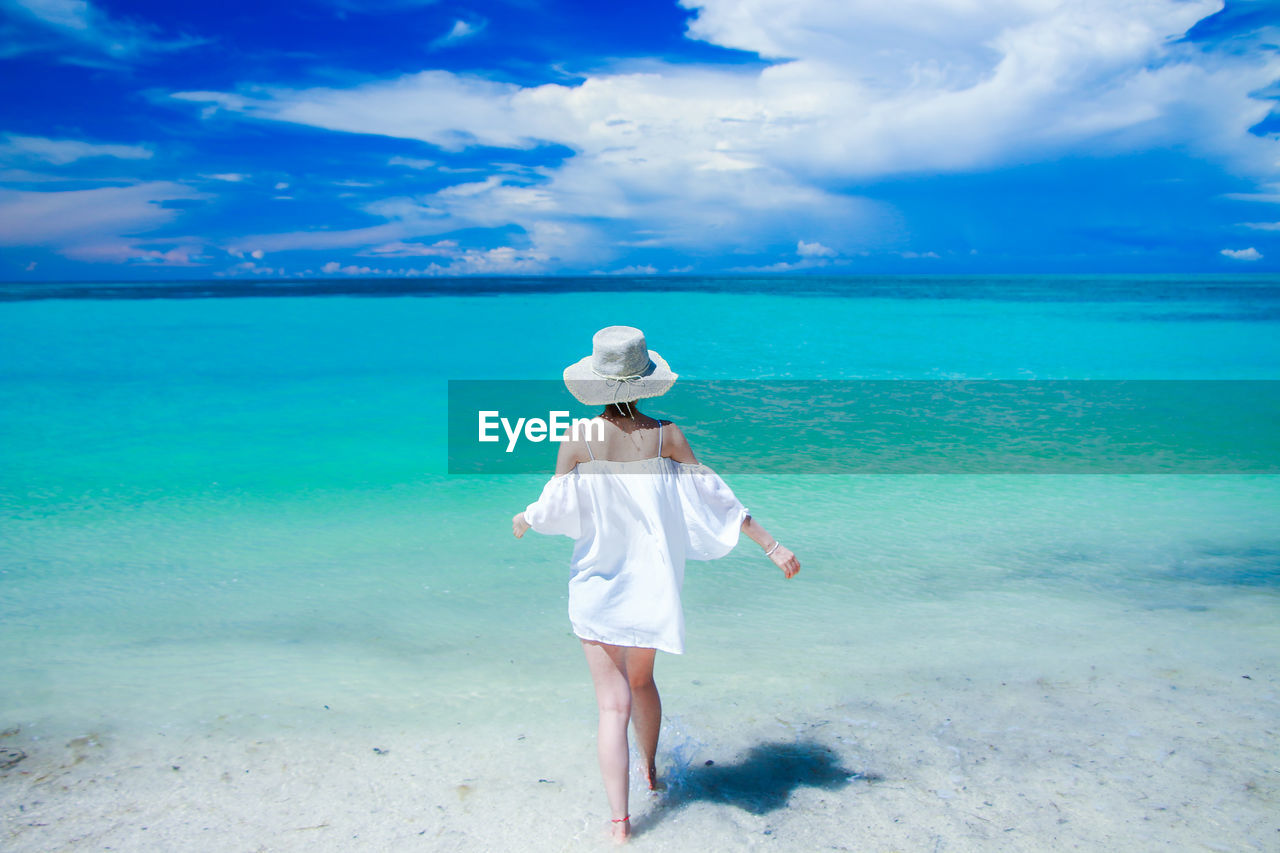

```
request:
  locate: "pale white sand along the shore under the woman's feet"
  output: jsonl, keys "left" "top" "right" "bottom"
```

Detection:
{"left": 0, "top": 658, "right": 1280, "bottom": 853}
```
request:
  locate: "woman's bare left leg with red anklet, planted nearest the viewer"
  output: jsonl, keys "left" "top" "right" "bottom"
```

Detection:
{"left": 582, "top": 640, "right": 631, "bottom": 841}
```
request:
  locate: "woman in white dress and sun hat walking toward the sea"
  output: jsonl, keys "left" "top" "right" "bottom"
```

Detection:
{"left": 512, "top": 325, "right": 800, "bottom": 841}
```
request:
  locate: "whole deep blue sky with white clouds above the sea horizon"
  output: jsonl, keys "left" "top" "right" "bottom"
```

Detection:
{"left": 0, "top": 0, "right": 1280, "bottom": 280}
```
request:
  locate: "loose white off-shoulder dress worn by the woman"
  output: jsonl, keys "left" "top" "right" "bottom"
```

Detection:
{"left": 525, "top": 424, "right": 748, "bottom": 654}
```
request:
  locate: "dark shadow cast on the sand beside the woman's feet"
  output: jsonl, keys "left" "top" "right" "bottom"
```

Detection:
{"left": 659, "top": 740, "right": 881, "bottom": 815}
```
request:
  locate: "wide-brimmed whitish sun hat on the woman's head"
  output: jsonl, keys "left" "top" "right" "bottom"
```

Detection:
{"left": 564, "top": 325, "right": 677, "bottom": 406}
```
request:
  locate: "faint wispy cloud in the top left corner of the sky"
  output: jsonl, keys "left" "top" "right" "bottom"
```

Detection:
{"left": 0, "top": 0, "right": 207, "bottom": 65}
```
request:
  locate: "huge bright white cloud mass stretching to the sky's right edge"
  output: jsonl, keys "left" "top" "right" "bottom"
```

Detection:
{"left": 173, "top": 0, "right": 1280, "bottom": 268}
